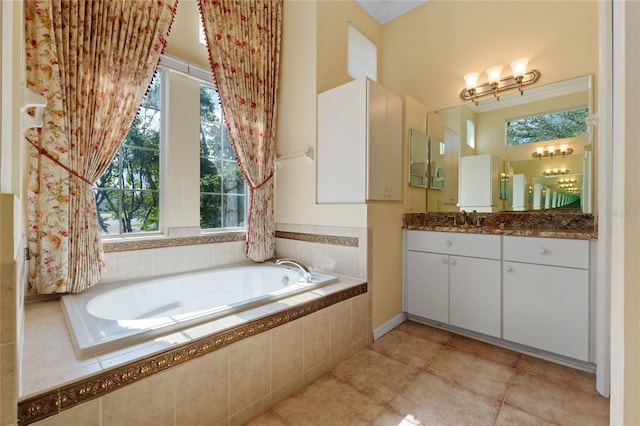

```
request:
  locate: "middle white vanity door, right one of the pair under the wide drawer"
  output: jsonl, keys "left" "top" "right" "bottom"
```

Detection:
{"left": 449, "top": 256, "right": 501, "bottom": 338}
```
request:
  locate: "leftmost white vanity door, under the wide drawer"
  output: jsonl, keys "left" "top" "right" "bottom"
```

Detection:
{"left": 406, "top": 251, "right": 449, "bottom": 324}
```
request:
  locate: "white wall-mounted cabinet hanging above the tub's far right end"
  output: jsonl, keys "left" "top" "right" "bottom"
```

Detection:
{"left": 317, "top": 79, "right": 403, "bottom": 203}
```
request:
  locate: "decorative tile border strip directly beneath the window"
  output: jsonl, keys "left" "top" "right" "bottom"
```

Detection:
{"left": 103, "top": 231, "right": 247, "bottom": 253}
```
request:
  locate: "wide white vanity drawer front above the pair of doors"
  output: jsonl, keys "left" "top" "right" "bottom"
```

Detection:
{"left": 407, "top": 231, "right": 500, "bottom": 259}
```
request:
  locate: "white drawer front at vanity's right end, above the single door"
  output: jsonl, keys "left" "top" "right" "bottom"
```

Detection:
{"left": 503, "top": 236, "right": 589, "bottom": 269}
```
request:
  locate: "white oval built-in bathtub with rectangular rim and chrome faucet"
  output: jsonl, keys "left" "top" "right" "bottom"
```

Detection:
{"left": 61, "top": 264, "right": 338, "bottom": 358}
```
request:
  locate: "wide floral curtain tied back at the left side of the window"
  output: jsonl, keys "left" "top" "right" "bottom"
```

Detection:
{"left": 24, "top": 0, "right": 177, "bottom": 293}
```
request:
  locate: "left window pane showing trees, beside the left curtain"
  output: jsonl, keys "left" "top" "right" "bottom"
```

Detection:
{"left": 94, "top": 72, "right": 164, "bottom": 234}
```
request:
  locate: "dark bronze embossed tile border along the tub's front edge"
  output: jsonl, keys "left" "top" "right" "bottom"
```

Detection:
{"left": 18, "top": 283, "right": 367, "bottom": 425}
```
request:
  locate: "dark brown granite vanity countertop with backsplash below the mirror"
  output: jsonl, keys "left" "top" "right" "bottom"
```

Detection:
{"left": 402, "top": 212, "right": 598, "bottom": 240}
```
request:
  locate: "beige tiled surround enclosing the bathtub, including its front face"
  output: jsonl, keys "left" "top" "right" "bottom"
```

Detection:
{"left": 19, "top": 225, "right": 372, "bottom": 424}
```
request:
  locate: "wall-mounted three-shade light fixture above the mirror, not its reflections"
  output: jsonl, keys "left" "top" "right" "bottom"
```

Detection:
{"left": 460, "top": 58, "right": 540, "bottom": 105}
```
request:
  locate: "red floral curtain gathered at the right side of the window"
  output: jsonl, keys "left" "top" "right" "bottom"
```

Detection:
{"left": 199, "top": 0, "right": 282, "bottom": 262}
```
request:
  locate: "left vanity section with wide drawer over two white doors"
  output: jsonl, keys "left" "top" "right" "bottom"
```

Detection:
{"left": 405, "top": 231, "right": 501, "bottom": 337}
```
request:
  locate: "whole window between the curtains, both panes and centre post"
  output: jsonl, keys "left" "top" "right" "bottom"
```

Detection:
{"left": 94, "top": 55, "right": 248, "bottom": 235}
